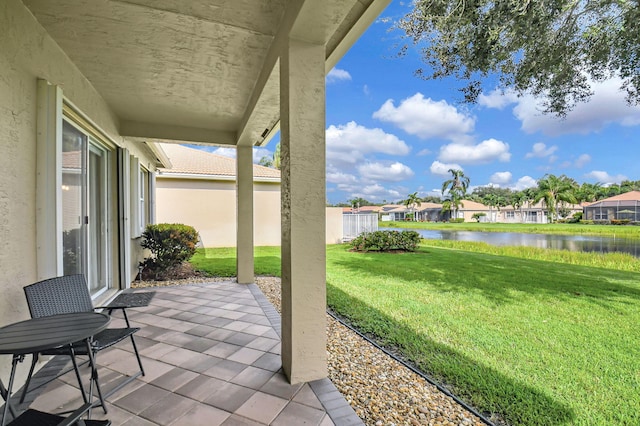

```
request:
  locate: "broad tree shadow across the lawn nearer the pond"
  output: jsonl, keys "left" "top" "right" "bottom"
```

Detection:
{"left": 331, "top": 248, "right": 640, "bottom": 308}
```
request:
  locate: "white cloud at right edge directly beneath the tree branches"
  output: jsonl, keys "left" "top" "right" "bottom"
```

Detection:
{"left": 498, "top": 78, "right": 640, "bottom": 136}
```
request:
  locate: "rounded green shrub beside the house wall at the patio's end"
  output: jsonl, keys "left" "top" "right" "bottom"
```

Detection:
{"left": 140, "top": 223, "right": 199, "bottom": 280}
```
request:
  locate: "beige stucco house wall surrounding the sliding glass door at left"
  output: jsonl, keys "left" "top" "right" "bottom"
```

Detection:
{"left": 0, "top": 0, "right": 159, "bottom": 377}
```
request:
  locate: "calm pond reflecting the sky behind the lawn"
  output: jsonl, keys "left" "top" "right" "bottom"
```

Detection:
{"left": 380, "top": 228, "right": 640, "bottom": 258}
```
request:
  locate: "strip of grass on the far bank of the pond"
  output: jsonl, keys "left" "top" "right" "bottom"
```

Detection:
{"left": 380, "top": 222, "right": 640, "bottom": 239}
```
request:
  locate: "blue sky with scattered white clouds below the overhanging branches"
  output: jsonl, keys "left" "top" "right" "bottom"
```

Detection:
{"left": 199, "top": 0, "right": 640, "bottom": 203}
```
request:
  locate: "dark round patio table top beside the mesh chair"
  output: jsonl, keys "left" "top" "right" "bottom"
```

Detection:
{"left": 0, "top": 312, "right": 110, "bottom": 355}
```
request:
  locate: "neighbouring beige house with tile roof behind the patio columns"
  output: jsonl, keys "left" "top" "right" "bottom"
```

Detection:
{"left": 155, "top": 143, "right": 342, "bottom": 247}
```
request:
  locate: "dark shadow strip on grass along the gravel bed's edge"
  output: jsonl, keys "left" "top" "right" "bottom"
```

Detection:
{"left": 327, "top": 282, "right": 575, "bottom": 425}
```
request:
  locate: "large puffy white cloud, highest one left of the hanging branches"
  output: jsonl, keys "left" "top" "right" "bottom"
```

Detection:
{"left": 373, "top": 93, "right": 475, "bottom": 142}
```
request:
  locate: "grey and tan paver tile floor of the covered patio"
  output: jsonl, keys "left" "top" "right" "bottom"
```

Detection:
{"left": 2, "top": 282, "right": 362, "bottom": 426}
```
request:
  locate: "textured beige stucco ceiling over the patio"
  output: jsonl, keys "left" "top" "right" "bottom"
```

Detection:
{"left": 24, "top": 0, "right": 390, "bottom": 145}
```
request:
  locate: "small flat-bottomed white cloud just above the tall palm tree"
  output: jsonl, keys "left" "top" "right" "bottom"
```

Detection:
{"left": 438, "top": 138, "right": 511, "bottom": 164}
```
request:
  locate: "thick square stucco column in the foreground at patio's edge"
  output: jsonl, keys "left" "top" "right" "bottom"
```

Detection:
{"left": 280, "top": 40, "right": 327, "bottom": 384}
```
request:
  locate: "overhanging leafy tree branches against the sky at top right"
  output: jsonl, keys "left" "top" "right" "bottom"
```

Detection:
{"left": 398, "top": 0, "right": 640, "bottom": 116}
